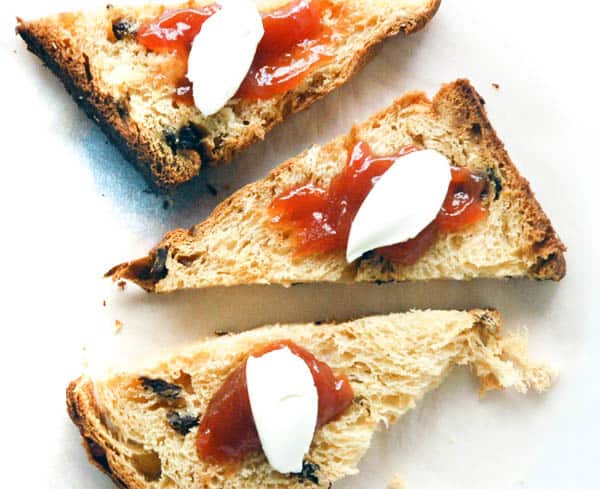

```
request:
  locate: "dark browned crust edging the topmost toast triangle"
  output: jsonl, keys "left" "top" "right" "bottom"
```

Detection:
{"left": 16, "top": 0, "right": 441, "bottom": 192}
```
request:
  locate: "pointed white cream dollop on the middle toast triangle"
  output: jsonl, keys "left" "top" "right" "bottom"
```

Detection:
{"left": 346, "top": 149, "right": 452, "bottom": 263}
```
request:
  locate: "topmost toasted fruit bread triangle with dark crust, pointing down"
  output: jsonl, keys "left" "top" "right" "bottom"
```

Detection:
{"left": 17, "top": 0, "right": 441, "bottom": 190}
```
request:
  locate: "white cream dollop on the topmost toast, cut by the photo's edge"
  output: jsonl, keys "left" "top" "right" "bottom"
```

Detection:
{"left": 187, "top": 0, "right": 264, "bottom": 116}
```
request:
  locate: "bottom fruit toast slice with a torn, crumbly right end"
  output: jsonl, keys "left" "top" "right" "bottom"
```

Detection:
{"left": 67, "top": 310, "right": 552, "bottom": 489}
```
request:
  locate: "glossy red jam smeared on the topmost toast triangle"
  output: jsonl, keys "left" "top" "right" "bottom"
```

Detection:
{"left": 137, "top": 0, "right": 333, "bottom": 105}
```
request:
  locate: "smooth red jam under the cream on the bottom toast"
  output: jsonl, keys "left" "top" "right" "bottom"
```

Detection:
{"left": 196, "top": 340, "right": 354, "bottom": 463}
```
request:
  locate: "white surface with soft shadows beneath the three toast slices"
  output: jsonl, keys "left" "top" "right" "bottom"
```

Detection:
{"left": 0, "top": 0, "right": 600, "bottom": 489}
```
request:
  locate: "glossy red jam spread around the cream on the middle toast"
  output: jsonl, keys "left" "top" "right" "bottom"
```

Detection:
{"left": 269, "top": 142, "right": 487, "bottom": 265}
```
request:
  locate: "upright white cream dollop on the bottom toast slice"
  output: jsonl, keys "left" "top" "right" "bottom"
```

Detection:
{"left": 246, "top": 347, "right": 319, "bottom": 474}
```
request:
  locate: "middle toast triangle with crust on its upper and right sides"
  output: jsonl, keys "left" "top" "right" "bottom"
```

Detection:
{"left": 107, "top": 80, "right": 566, "bottom": 292}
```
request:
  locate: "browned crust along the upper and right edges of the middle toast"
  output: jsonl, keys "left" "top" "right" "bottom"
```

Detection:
{"left": 106, "top": 79, "right": 566, "bottom": 292}
